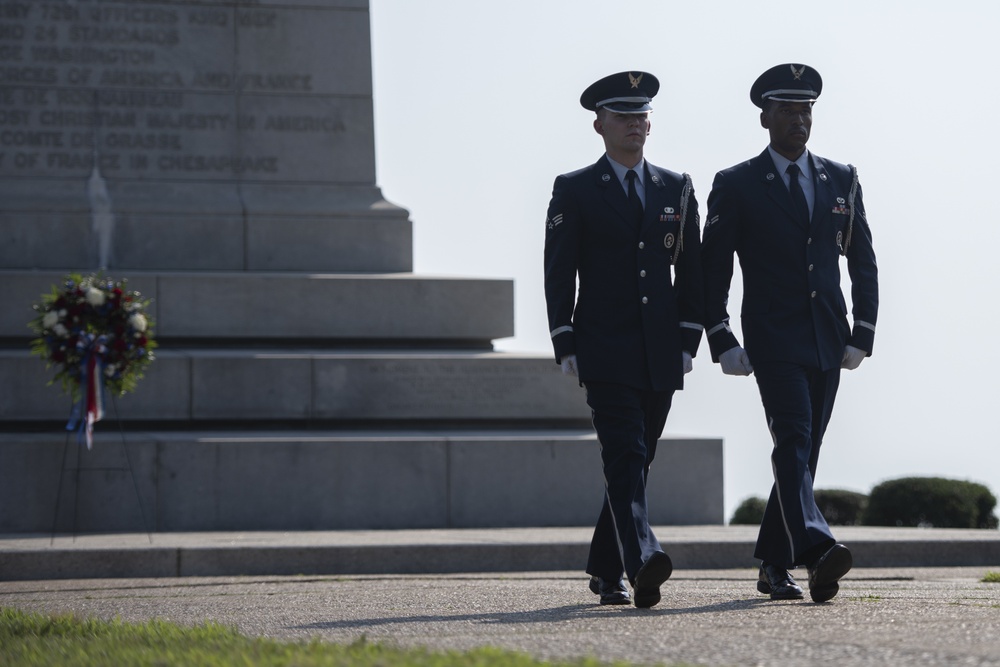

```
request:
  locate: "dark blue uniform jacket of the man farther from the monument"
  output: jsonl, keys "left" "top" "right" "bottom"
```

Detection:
{"left": 702, "top": 149, "right": 878, "bottom": 370}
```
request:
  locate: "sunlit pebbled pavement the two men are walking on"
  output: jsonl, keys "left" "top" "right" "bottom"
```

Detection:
{"left": 0, "top": 567, "right": 1000, "bottom": 667}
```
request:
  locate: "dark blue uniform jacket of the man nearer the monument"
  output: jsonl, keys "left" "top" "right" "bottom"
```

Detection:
{"left": 545, "top": 156, "right": 704, "bottom": 391}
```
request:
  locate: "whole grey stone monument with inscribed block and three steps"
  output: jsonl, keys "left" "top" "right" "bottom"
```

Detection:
{"left": 0, "top": 0, "right": 722, "bottom": 532}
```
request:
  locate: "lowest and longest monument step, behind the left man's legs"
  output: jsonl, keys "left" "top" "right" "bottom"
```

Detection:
{"left": 0, "top": 434, "right": 724, "bottom": 533}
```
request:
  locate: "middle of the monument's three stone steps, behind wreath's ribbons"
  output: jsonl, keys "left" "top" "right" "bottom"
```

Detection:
{"left": 0, "top": 348, "right": 590, "bottom": 426}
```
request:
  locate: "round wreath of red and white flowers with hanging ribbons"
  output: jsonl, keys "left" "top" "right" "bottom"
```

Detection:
{"left": 28, "top": 274, "right": 156, "bottom": 449}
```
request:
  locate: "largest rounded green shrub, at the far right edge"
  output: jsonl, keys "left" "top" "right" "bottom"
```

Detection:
{"left": 862, "top": 477, "right": 997, "bottom": 528}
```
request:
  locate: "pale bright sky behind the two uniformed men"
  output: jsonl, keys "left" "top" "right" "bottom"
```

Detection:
{"left": 371, "top": 0, "right": 1000, "bottom": 520}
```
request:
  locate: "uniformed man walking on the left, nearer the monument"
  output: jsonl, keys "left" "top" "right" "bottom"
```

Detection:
{"left": 545, "top": 71, "right": 704, "bottom": 607}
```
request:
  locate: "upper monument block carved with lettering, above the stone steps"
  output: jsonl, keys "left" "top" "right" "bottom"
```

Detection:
{"left": 0, "top": 0, "right": 412, "bottom": 273}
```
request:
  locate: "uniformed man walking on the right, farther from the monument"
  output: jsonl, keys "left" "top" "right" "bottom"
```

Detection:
{"left": 702, "top": 63, "right": 878, "bottom": 602}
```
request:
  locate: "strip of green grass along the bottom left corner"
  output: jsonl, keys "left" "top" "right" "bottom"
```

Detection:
{"left": 0, "top": 609, "right": 672, "bottom": 667}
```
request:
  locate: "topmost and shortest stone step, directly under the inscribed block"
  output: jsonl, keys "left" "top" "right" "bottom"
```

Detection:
{"left": 0, "top": 270, "right": 514, "bottom": 349}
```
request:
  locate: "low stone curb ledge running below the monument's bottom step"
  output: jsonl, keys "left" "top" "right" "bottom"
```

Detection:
{"left": 0, "top": 526, "right": 1000, "bottom": 581}
